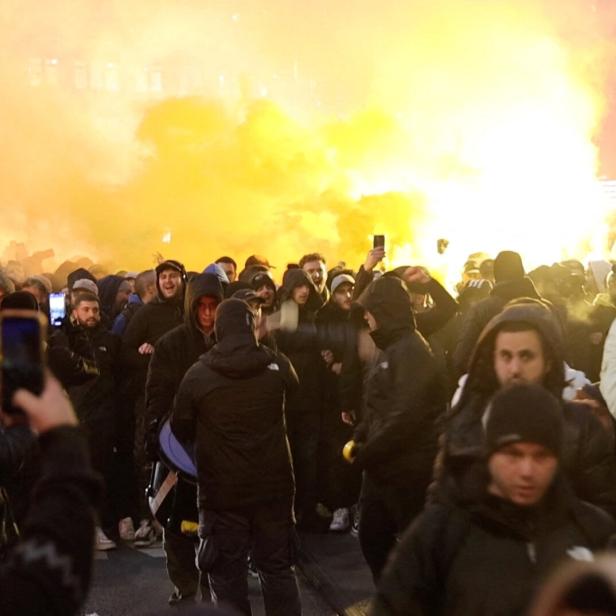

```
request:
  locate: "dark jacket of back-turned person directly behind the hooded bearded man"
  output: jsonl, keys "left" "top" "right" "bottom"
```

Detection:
{"left": 453, "top": 276, "right": 541, "bottom": 375}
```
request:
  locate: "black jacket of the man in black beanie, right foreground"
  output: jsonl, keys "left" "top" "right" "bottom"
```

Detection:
{"left": 371, "top": 466, "right": 616, "bottom": 616}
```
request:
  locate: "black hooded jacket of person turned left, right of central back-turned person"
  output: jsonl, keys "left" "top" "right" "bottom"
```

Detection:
{"left": 354, "top": 276, "right": 446, "bottom": 487}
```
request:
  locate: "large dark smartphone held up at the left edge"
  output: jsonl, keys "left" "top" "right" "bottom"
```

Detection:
{"left": 0, "top": 310, "right": 46, "bottom": 414}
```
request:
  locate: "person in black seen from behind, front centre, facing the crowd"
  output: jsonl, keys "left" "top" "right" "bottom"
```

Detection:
{"left": 171, "top": 298, "right": 301, "bottom": 616}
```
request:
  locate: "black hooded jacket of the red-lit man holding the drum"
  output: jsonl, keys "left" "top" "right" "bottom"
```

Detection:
{"left": 142, "top": 274, "right": 223, "bottom": 442}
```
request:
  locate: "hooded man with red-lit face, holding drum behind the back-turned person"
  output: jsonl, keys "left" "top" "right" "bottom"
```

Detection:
{"left": 142, "top": 274, "right": 224, "bottom": 604}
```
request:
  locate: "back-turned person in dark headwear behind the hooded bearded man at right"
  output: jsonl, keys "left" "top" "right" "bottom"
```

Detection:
{"left": 453, "top": 250, "right": 541, "bottom": 376}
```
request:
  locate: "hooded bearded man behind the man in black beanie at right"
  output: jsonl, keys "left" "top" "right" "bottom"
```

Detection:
{"left": 431, "top": 302, "right": 616, "bottom": 515}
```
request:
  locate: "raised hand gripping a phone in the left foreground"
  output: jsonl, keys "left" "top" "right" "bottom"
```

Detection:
{"left": 13, "top": 374, "right": 77, "bottom": 434}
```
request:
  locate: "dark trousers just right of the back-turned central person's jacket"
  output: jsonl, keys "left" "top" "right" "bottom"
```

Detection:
{"left": 286, "top": 411, "right": 321, "bottom": 518}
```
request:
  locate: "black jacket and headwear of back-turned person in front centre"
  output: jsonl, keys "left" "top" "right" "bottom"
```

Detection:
{"left": 171, "top": 299, "right": 297, "bottom": 510}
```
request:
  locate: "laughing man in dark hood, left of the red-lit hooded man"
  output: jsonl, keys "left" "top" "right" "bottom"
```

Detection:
{"left": 121, "top": 259, "right": 186, "bottom": 547}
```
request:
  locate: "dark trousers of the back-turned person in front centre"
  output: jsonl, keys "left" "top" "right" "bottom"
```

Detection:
{"left": 200, "top": 499, "right": 301, "bottom": 616}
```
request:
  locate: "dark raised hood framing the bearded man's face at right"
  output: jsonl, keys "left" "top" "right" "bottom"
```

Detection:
{"left": 458, "top": 302, "right": 565, "bottom": 406}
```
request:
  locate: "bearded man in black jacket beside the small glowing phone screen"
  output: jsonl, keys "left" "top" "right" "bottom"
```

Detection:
{"left": 49, "top": 292, "right": 118, "bottom": 550}
